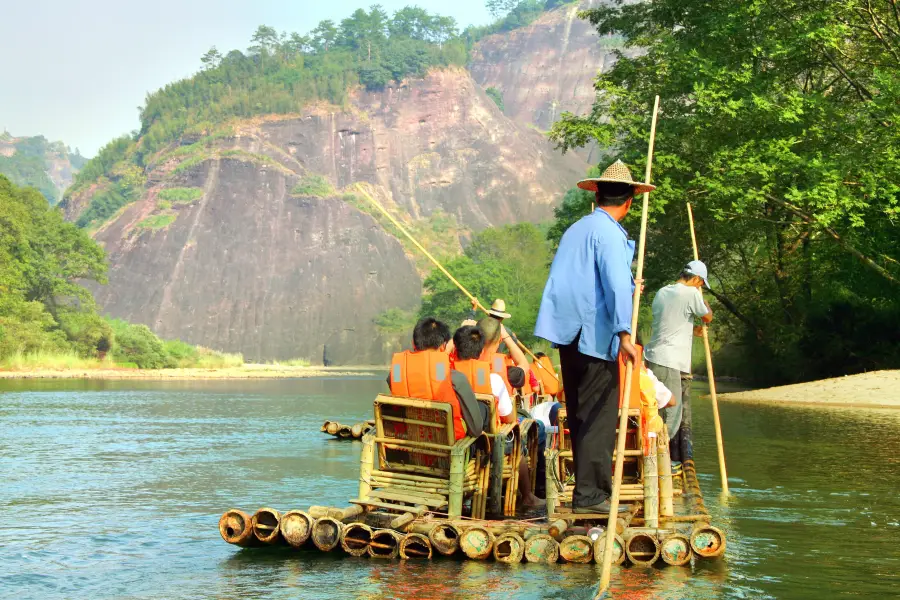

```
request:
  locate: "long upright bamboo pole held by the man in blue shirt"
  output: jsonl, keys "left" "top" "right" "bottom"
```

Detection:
{"left": 598, "top": 96, "right": 659, "bottom": 596}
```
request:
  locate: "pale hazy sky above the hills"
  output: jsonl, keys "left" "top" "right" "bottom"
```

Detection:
{"left": 0, "top": 0, "right": 490, "bottom": 156}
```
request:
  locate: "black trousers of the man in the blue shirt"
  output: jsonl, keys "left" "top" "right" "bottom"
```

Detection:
{"left": 559, "top": 337, "right": 619, "bottom": 507}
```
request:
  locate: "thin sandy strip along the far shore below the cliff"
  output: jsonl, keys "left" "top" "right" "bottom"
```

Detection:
{"left": 0, "top": 365, "right": 387, "bottom": 379}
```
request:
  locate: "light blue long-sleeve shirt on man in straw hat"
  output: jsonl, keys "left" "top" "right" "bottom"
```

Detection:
{"left": 534, "top": 208, "right": 634, "bottom": 361}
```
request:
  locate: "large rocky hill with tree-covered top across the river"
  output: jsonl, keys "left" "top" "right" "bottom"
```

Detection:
{"left": 62, "top": 0, "right": 620, "bottom": 364}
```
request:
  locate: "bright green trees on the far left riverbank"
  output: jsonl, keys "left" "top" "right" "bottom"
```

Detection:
{"left": 0, "top": 175, "right": 243, "bottom": 368}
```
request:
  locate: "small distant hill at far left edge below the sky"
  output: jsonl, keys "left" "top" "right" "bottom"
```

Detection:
{"left": 0, "top": 131, "right": 87, "bottom": 204}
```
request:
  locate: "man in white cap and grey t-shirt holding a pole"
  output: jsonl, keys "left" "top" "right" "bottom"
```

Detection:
{"left": 645, "top": 260, "right": 712, "bottom": 474}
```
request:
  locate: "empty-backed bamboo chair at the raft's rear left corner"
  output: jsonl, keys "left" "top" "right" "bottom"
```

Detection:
{"left": 355, "top": 394, "right": 488, "bottom": 519}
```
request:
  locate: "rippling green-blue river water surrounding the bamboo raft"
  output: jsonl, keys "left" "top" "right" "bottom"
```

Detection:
{"left": 0, "top": 377, "right": 900, "bottom": 600}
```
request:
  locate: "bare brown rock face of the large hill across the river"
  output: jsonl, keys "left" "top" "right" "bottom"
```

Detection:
{"left": 84, "top": 69, "right": 585, "bottom": 364}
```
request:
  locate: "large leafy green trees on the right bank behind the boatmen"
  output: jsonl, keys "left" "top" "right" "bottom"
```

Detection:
{"left": 551, "top": 0, "right": 900, "bottom": 381}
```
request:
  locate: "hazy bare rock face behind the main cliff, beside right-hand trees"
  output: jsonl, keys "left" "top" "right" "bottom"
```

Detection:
{"left": 469, "top": 0, "right": 630, "bottom": 162}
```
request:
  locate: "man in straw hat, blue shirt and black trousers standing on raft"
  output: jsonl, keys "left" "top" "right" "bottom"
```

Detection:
{"left": 534, "top": 161, "right": 655, "bottom": 513}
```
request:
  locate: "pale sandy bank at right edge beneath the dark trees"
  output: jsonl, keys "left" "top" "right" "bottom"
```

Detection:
{"left": 719, "top": 371, "right": 900, "bottom": 408}
